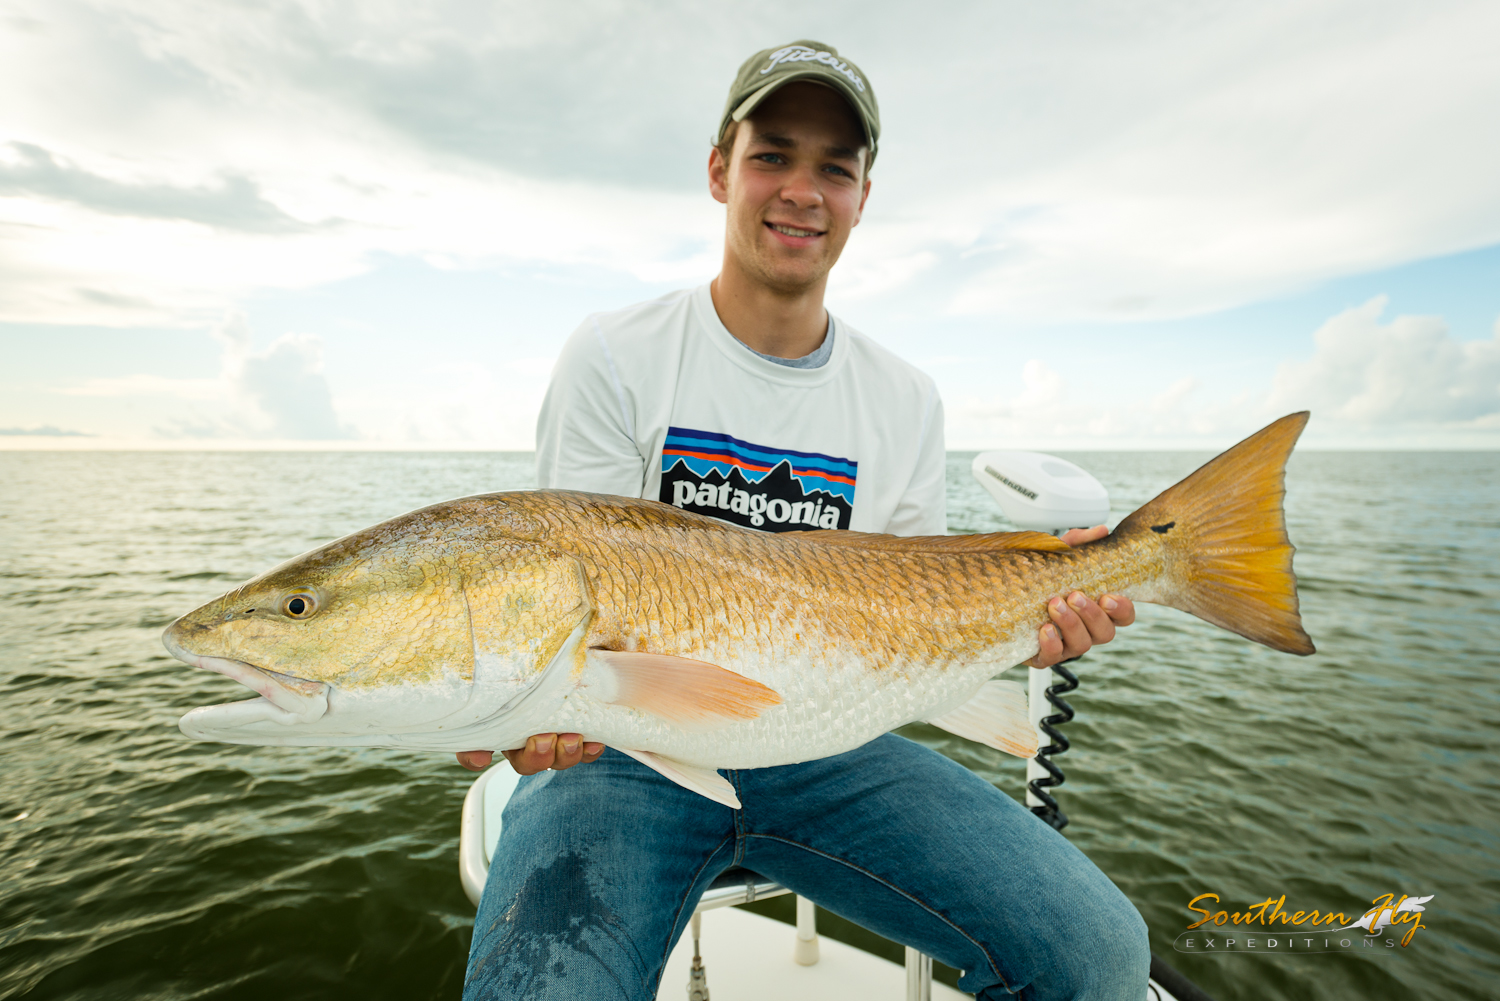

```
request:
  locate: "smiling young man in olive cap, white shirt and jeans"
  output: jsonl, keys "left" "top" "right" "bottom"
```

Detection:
{"left": 459, "top": 42, "right": 1149, "bottom": 1001}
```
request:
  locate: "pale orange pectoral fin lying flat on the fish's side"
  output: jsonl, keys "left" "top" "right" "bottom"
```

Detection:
{"left": 587, "top": 650, "right": 782, "bottom": 729}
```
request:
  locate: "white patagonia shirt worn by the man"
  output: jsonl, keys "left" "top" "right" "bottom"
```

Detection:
{"left": 537, "top": 285, "right": 947, "bottom": 536}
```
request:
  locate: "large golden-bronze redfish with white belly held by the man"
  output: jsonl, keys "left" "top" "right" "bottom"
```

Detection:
{"left": 165, "top": 413, "right": 1313, "bottom": 806}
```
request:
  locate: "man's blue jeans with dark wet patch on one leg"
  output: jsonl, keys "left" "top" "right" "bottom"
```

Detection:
{"left": 464, "top": 734, "right": 1151, "bottom": 1001}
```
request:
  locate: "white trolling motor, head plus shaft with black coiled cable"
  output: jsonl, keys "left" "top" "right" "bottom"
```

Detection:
{"left": 971, "top": 452, "right": 1110, "bottom": 830}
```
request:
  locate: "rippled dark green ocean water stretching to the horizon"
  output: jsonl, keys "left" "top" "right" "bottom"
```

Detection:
{"left": 0, "top": 452, "right": 1500, "bottom": 1001}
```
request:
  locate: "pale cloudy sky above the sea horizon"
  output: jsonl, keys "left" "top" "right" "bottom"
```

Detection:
{"left": 0, "top": 0, "right": 1500, "bottom": 450}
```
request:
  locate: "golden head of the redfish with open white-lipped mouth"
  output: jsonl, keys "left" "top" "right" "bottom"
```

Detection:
{"left": 162, "top": 501, "right": 591, "bottom": 744}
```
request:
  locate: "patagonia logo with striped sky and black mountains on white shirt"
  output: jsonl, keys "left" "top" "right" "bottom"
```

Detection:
{"left": 660, "top": 428, "right": 858, "bottom": 531}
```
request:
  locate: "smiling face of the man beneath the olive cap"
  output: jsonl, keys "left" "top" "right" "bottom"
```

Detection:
{"left": 708, "top": 83, "right": 870, "bottom": 294}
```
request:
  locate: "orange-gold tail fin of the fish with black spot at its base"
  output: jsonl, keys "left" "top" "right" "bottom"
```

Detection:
{"left": 1115, "top": 411, "right": 1314, "bottom": 656}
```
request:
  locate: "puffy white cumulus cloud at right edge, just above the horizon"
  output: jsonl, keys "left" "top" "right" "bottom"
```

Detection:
{"left": 1268, "top": 296, "right": 1500, "bottom": 431}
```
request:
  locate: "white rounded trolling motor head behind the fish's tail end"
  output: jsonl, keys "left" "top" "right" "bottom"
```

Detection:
{"left": 972, "top": 452, "right": 1110, "bottom": 536}
